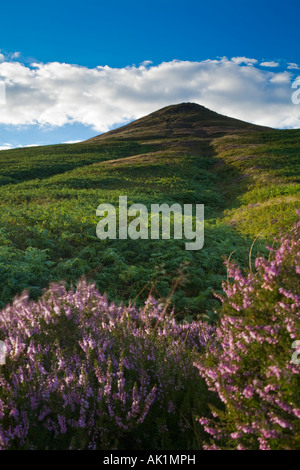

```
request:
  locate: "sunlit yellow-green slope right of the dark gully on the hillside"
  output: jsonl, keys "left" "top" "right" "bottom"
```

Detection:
{"left": 215, "top": 130, "right": 300, "bottom": 238}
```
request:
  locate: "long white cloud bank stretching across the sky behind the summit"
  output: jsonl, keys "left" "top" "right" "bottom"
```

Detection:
{"left": 0, "top": 57, "right": 300, "bottom": 132}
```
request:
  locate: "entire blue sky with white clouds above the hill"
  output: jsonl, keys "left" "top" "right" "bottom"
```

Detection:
{"left": 0, "top": 0, "right": 300, "bottom": 149}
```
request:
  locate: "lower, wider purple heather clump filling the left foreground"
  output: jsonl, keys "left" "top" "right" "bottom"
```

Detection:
{"left": 0, "top": 281, "right": 214, "bottom": 449}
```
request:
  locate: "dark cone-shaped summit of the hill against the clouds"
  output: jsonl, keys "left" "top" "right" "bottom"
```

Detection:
{"left": 87, "top": 102, "right": 266, "bottom": 142}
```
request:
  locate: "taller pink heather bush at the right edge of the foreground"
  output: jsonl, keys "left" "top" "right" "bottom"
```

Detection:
{"left": 197, "top": 217, "right": 300, "bottom": 450}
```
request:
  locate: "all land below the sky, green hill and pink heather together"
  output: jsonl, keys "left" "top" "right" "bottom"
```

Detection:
{"left": 0, "top": 104, "right": 300, "bottom": 450}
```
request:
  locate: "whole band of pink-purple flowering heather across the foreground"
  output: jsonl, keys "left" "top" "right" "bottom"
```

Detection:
{"left": 0, "top": 222, "right": 300, "bottom": 450}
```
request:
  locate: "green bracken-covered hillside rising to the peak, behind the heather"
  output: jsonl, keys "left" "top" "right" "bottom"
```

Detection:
{"left": 0, "top": 104, "right": 300, "bottom": 318}
